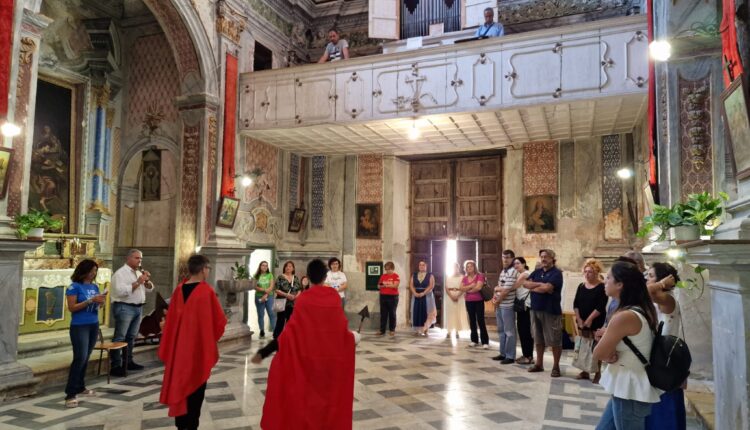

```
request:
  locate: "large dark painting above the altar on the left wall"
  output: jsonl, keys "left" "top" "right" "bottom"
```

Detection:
{"left": 29, "top": 78, "right": 76, "bottom": 232}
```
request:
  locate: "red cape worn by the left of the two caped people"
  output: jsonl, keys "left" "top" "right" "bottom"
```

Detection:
{"left": 159, "top": 281, "right": 227, "bottom": 417}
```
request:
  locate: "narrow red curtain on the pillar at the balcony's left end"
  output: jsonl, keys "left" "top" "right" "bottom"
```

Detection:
{"left": 221, "top": 54, "right": 237, "bottom": 197}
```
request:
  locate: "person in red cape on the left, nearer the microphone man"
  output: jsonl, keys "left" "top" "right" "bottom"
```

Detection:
{"left": 159, "top": 255, "right": 227, "bottom": 429}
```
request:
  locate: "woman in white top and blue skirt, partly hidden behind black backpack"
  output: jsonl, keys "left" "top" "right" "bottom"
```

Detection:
{"left": 646, "top": 263, "right": 687, "bottom": 430}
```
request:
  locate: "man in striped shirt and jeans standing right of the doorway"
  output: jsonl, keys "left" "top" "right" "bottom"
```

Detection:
{"left": 492, "top": 249, "right": 518, "bottom": 364}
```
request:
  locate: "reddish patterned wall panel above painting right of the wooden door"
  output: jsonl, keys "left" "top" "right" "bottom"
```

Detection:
{"left": 523, "top": 141, "right": 558, "bottom": 196}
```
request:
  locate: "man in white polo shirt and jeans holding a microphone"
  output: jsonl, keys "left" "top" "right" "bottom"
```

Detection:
{"left": 110, "top": 249, "right": 154, "bottom": 376}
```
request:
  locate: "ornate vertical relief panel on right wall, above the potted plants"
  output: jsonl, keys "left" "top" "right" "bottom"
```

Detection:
{"left": 679, "top": 76, "right": 713, "bottom": 200}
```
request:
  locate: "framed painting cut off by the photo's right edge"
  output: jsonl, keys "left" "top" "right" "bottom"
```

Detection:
{"left": 721, "top": 74, "right": 750, "bottom": 179}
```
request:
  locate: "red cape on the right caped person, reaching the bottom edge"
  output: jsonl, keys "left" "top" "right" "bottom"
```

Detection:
{"left": 260, "top": 286, "right": 354, "bottom": 430}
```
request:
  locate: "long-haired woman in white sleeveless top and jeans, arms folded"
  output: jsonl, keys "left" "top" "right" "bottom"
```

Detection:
{"left": 594, "top": 262, "right": 661, "bottom": 430}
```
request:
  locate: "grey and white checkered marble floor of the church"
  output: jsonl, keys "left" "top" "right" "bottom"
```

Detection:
{"left": 0, "top": 331, "right": 700, "bottom": 430}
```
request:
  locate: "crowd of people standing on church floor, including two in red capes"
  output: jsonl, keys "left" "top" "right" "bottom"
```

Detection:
{"left": 65, "top": 244, "right": 686, "bottom": 429}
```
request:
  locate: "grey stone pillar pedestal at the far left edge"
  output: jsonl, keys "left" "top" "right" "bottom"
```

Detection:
{"left": 0, "top": 239, "right": 40, "bottom": 401}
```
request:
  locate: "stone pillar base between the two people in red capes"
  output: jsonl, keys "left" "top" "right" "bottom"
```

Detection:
{"left": 201, "top": 246, "right": 253, "bottom": 340}
